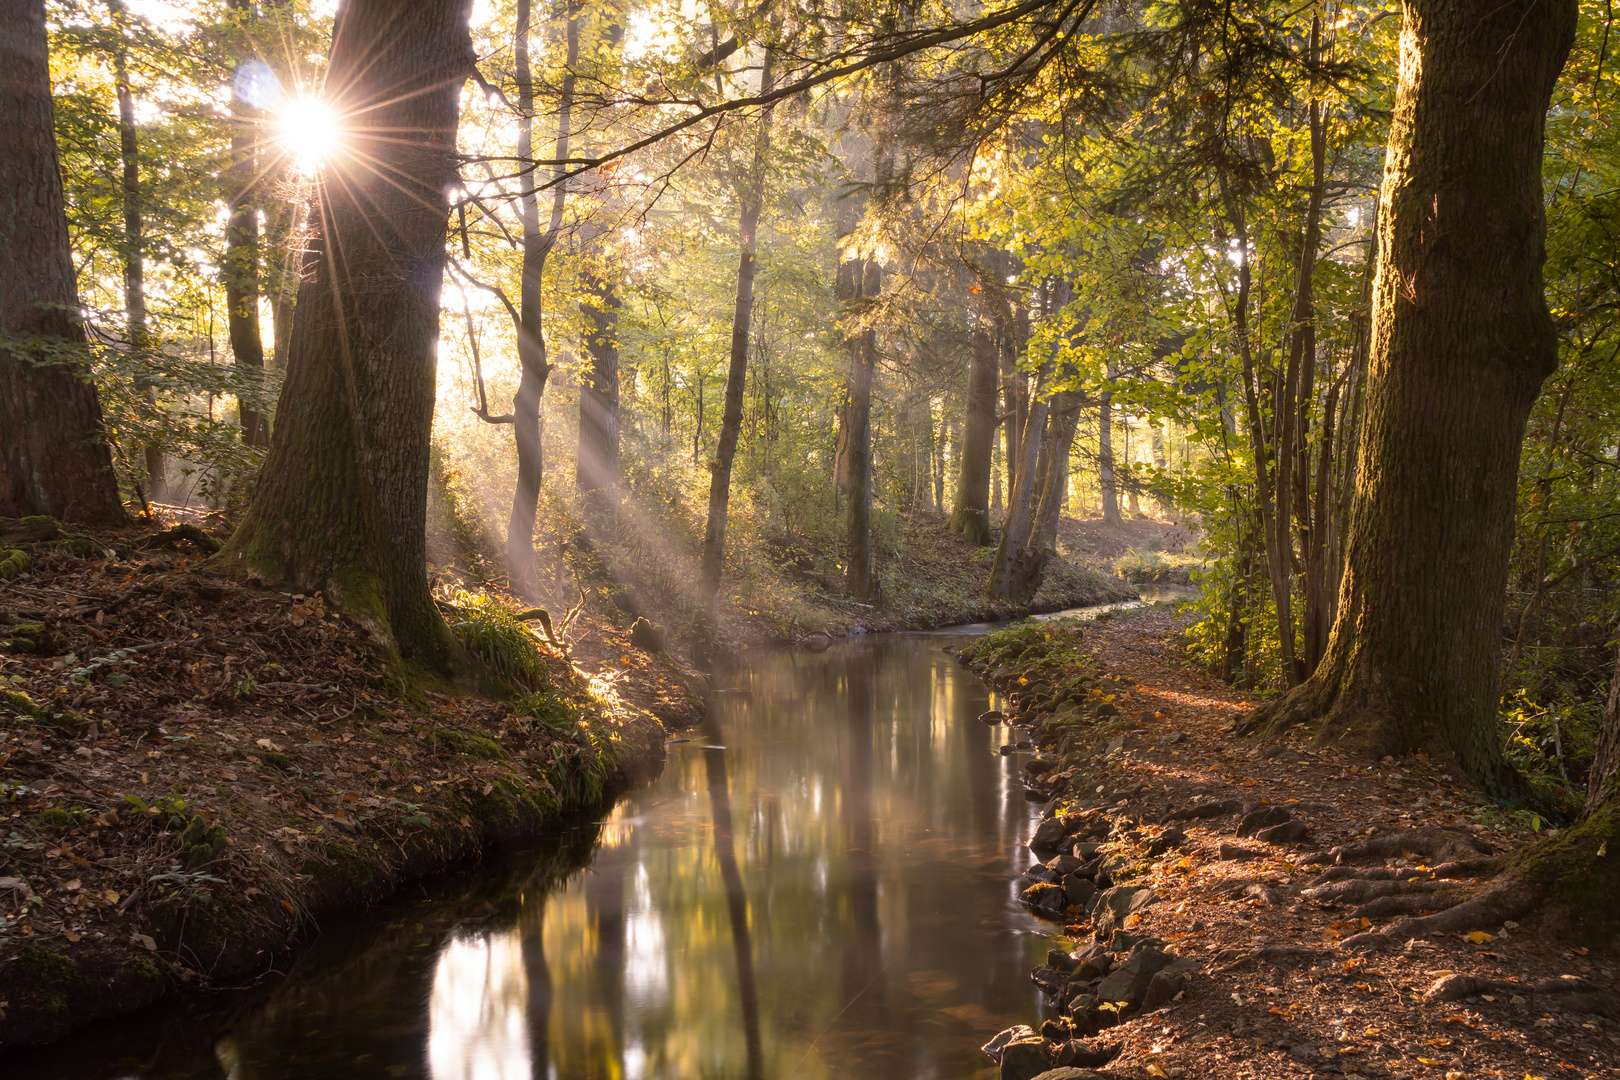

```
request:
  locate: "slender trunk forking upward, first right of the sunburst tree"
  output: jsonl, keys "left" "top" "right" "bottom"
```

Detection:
{"left": 507, "top": 0, "right": 580, "bottom": 601}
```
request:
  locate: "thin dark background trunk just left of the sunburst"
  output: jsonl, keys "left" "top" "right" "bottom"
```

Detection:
{"left": 224, "top": 0, "right": 271, "bottom": 447}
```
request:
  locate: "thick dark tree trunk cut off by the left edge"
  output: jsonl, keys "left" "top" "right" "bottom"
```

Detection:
{"left": 0, "top": 2, "right": 125, "bottom": 525}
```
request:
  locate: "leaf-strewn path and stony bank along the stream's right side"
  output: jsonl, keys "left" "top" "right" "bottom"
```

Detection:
{"left": 964, "top": 609, "right": 1620, "bottom": 1080}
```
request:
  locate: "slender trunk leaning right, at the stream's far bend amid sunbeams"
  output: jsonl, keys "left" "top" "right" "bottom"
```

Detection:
{"left": 698, "top": 49, "right": 771, "bottom": 604}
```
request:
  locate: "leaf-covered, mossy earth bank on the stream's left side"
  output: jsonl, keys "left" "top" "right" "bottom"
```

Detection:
{"left": 0, "top": 521, "right": 698, "bottom": 1046}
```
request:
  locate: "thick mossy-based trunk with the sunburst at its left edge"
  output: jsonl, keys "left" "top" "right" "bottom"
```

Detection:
{"left": 219, "top": 0, "right": 471, "bottom": 662}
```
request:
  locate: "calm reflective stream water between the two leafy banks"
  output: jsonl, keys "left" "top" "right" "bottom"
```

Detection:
{"left": 15, "top": 633, "right": 1088, "bottom": 1080}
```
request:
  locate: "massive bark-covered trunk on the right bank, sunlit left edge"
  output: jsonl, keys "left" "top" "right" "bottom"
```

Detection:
{"left": 1259, "top": 0, "right": 1575, "bottom": 785}
